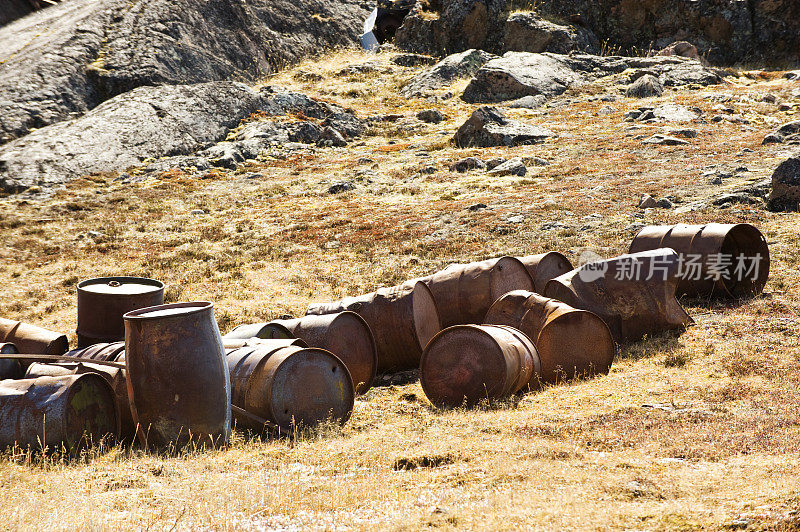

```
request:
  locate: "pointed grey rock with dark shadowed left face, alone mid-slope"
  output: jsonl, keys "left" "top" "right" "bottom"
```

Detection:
{"left": 453, "top": 107, "right": 555, "bottom": 148}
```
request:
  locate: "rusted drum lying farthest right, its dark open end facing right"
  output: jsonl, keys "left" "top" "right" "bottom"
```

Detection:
{"left": 630, "top": 223, "right": 770, "bottom": 298}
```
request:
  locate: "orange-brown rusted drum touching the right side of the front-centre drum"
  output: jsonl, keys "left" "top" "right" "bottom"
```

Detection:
{"left": 486, "top": 290, "right": 616, "bottom": 384}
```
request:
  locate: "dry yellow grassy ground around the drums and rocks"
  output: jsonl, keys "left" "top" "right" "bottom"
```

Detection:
{"left": 0, "top": 47, "right": 800, "bottom": 530}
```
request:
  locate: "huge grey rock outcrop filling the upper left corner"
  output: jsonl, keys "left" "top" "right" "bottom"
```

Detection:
{"left": 0, "top": 0, "right": 368, "bottom": 144}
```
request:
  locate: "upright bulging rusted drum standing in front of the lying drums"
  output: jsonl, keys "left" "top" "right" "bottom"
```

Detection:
{"left": 124, "top": 301, "right": 231, "bottom": 447}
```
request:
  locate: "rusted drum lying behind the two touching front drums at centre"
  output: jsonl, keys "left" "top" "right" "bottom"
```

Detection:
{"left": 420, "top": 257, "right": 533, "bottom": 327}
